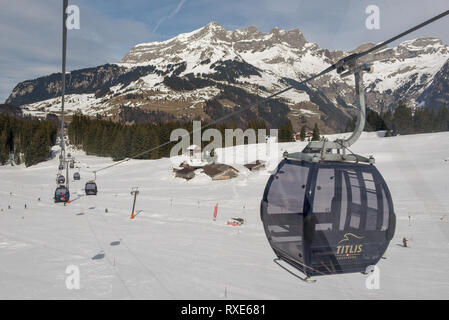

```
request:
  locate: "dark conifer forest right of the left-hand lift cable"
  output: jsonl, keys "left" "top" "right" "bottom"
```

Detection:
{"left": 68, "top": 102, "right": 449, "bottom": 161}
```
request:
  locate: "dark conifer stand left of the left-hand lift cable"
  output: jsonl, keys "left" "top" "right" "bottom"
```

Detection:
{"left": 0, "top": 114, "right": 58, "bottom": 167}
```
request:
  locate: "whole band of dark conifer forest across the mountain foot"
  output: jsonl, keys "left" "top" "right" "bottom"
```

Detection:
{"left": 0, "top": 101, "right": 449, "bottom": 166}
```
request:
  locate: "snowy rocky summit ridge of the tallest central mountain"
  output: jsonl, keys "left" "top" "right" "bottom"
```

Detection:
{"left": 121, "top": 22, "right": 307, "bottom": 65}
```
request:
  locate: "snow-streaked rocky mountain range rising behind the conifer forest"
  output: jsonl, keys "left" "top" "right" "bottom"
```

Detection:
{"left": 6, "top": 22, "right": 449, "bottom": 133}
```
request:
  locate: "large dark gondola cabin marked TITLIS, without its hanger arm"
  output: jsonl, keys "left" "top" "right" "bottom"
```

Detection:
{"left": 261, "top": 159, "right": 396, "bottom": 277}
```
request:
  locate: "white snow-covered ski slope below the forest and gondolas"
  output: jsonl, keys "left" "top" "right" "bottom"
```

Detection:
{"left": 0, "top": 132, "right": 449, "bottom": 299}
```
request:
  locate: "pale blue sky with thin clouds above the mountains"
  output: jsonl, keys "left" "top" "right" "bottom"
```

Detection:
{"left": 0, "top": 0, "right": 449, "bottom": 101}
